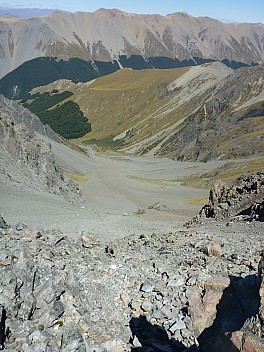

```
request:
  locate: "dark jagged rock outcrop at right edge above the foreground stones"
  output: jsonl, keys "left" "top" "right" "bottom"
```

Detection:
{"left": 200, "top": 173, "right": 264, "bottom": 221}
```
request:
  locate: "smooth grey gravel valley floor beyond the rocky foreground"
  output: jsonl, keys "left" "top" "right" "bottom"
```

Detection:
{"left": 0, "top": 137, "right": 229, "bottom": 241}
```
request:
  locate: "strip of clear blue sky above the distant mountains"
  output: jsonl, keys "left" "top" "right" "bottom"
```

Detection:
{"left": 0, "top": 0, "right": 264, "bottom": 23}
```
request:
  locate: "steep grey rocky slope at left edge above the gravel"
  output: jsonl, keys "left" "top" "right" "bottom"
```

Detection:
{"left": 0, "top": 97, "right": 79, "bottom": 200}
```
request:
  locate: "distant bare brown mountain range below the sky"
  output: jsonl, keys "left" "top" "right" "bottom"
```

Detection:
{"left": 0, "top": 9, "right": 264, "bottom": 77}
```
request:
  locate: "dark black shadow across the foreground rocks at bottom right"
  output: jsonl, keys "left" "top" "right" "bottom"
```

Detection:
{"left": 130, "top": 275, "right": 260, "bottom": 352}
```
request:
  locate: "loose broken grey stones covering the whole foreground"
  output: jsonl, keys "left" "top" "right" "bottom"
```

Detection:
{"left": 0, "top": 219, "right": 264, "bottom": 352}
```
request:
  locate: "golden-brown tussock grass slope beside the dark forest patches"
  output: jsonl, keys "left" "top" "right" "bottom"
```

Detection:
{"left": 34, "top": 67, "right": 190, "bottom": 149}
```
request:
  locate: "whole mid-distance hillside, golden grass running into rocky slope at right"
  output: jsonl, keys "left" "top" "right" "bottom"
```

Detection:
{"left": 25, "top": 63, "right": 264, "bottom": 173}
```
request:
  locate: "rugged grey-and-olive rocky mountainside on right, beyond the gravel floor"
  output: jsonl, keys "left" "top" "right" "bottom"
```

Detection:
{"left": 166, "top": 66, "right": 264, "bottom": 161}
